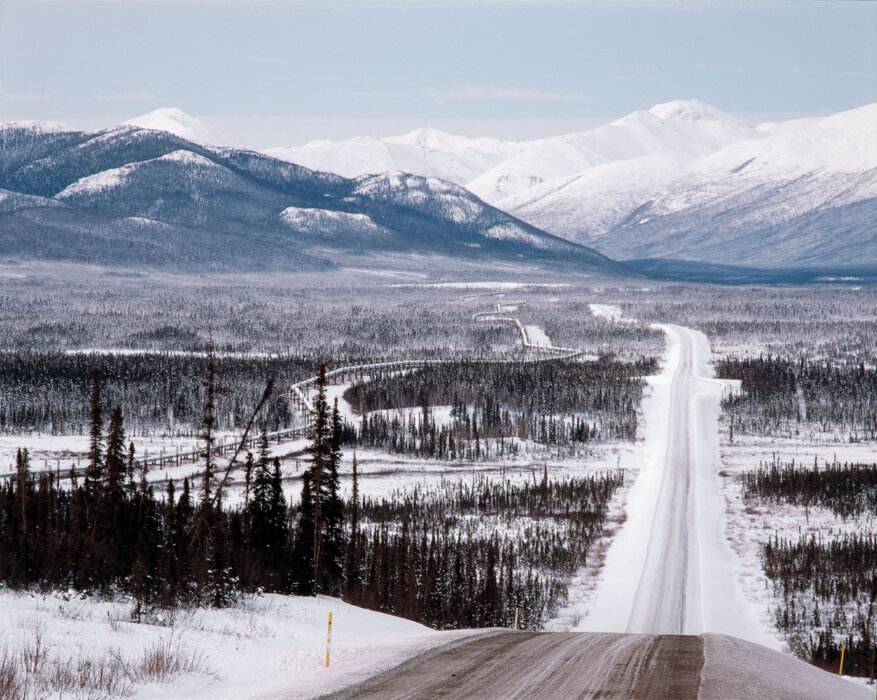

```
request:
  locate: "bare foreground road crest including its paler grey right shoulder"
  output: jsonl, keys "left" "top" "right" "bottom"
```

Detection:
{"left": 323, "top": 632, "right": 874, "bottom": 700}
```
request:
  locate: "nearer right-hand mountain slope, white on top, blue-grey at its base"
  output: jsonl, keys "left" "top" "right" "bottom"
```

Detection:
{"left": 506, "top": 105, "right": 877, "bottom": 267}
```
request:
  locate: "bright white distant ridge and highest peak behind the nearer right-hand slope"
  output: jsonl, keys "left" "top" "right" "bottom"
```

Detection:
{"left": 265, "top": 100, "right": 757, "bottom": 201}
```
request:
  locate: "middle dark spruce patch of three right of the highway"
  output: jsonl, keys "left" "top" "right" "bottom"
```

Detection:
{"left": 741, "top": 456, "right": 877, "bottom": 519}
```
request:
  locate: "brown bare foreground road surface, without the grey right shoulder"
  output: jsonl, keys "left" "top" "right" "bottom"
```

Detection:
{"left": 327, "top": 632, "right": 703, "bottom": 700}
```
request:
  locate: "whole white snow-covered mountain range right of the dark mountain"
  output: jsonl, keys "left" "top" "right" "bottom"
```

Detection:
{"left": 271, "top": 100, "right": 877, "bottom": 267}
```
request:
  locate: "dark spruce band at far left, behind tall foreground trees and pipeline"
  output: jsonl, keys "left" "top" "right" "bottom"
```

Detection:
{"left": 0, "top": 352, "right": 318, "bottom": 435}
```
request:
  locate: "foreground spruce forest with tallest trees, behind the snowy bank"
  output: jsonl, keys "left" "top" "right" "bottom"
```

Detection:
{"left": 0, "top": 366, "right": 622, "bottom": 628}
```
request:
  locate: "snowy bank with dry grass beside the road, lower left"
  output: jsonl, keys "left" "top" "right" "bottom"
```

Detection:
{"left": 0, "top": 591, "right": 479, "bottom": 700}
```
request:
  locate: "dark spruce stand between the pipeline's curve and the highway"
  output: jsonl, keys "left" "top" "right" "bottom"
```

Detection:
{"left": 344, "top": 358, "right": 654, "bottom": 460}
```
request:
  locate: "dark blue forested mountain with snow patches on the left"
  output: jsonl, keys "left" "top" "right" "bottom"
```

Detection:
{"left": 0, "top": 123, "right": 635, "bottom": 276}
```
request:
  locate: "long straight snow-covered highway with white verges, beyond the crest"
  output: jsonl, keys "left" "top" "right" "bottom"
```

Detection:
{"left": 576, "top": 325, "right": 779, "bottom": 649}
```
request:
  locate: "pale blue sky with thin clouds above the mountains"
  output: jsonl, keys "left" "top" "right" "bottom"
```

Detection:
{"left": 0, "top": 0, "right": 877, "bottom": 148}
